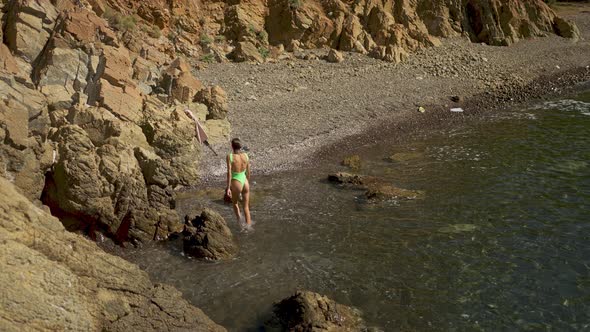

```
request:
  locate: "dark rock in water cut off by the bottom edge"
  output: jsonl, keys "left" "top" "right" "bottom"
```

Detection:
{"left": 269, "top": 291, "right": 366, "bottom": 332}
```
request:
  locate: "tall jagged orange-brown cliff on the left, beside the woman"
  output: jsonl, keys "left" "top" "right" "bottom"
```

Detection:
{"left": 0, "top": 0, "right": 229, "bottom": 242}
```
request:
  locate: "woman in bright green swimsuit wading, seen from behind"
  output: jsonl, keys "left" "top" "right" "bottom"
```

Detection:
{"left": 225, "top": 138, "right": 252, "bottom": 229}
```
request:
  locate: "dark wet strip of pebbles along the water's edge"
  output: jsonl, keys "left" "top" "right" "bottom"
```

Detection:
{"left": 195, "top": 67, "right": 590, "bottom": 191}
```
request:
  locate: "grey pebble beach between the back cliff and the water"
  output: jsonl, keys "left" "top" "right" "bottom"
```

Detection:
{"left": 194, "top": 11, "right": 590, "bottom": 184}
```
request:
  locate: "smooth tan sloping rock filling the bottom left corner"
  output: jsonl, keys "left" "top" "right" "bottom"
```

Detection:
{"left": 0, "top": 178, "right": 225, "bottom": 331}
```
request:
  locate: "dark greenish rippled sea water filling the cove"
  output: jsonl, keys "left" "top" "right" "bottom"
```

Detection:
{"left": 121, "top": 89, "right": 590, "bottom": 331}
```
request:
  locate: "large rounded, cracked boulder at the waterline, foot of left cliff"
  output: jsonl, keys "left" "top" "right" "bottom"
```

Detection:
{"left": 43, "top": 125, "right": 181, "bottom": 242}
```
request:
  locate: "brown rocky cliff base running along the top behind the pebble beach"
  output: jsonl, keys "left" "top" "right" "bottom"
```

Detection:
{"left": 46, "top": 0, "right": 579, "bottom": 62}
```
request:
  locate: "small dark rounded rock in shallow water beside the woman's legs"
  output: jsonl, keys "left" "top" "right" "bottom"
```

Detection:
{"left": 183, "top": 209, "right": 238, "bottom": 260}
